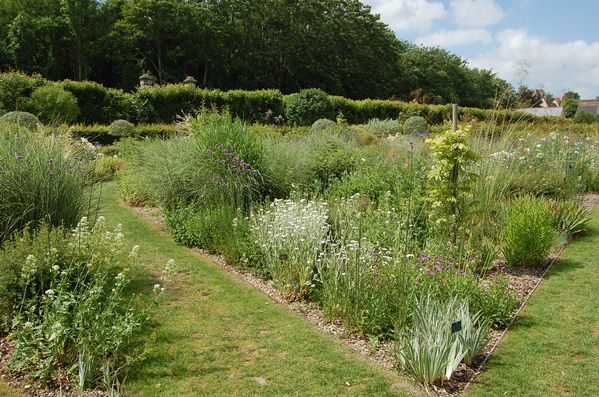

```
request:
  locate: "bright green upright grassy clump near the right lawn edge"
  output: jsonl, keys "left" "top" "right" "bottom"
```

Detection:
{"left": 501, "top": 196, "right": 556, "bottom": 266}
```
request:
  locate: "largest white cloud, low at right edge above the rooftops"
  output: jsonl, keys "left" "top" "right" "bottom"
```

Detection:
{"left": 470, "top": 29, "right": 599, "bottom": 98}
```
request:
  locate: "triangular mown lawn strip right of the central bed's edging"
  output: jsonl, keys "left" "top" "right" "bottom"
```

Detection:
{"left": 466, "top": 207, "right": 599, "bottom": 397}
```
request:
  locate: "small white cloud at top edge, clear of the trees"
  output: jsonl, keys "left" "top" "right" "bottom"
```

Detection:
{"left": 449, "top": 0, "right": 505, "bottom": 28}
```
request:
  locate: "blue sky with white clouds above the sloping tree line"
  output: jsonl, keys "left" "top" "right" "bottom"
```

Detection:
{"left": 362, "top": 0, "right": 599, "bottom": 99}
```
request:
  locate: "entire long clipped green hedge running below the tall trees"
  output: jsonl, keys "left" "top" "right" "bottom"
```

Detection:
{"left": 0, "top": 72, "right": 542, "bottom": 125}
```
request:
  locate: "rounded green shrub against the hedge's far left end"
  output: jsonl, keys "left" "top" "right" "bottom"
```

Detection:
{"left": 28, "top": 85, "right": 79, "bottom": 124}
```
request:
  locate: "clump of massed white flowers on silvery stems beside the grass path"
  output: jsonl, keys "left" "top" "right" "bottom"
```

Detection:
{"left": 251, "top": 200, "right": 329, "bottom": 300}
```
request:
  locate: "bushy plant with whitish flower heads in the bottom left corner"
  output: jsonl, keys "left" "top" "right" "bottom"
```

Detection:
{"left": 2, "top": 218, "right": 175, "bottom": 392}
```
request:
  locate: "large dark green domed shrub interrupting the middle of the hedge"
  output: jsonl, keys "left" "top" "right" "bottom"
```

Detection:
{"left": 285, "top": 89, "right": 335, "bottom": 126}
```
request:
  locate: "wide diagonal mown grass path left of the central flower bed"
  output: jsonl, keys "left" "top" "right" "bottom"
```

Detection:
{"left": 101, "top": 184, "right": 416, "bottom": 397}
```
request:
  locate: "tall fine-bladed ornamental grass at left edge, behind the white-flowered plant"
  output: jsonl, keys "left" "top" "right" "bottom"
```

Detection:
{"left": 0, "top": 125, "right": 90, "bottom": 241}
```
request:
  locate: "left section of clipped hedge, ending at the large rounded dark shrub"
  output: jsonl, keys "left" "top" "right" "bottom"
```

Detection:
{"left": 0, "top": 72, "right": 284, "bottom": 125}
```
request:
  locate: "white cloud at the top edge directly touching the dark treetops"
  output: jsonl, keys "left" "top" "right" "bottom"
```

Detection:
{"left": 364, "top": 0, "right": 446, "bottom": 32}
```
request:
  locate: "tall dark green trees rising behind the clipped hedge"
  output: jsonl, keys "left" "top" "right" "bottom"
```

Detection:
{"left": 0, "top": 0, "right": 513, "bottom": 108}
